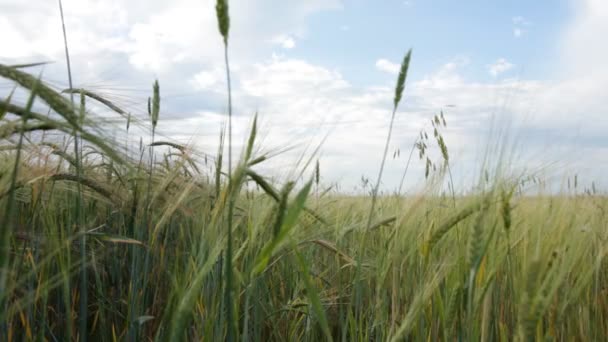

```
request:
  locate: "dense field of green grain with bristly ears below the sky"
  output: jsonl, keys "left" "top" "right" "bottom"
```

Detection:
{"left": 0, "top": 1, "right": 608, "bottom": 341}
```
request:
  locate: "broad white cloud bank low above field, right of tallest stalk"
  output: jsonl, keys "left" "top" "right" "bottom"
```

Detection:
{"left": 180, "top": 56, "right": 607, "bottom": 190}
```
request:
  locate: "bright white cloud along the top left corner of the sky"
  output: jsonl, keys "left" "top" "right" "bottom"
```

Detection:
{"left": 0, "top": 0, "right": 342, "bottom": 74}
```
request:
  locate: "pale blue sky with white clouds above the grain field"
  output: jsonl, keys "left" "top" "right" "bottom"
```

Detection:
{"left": 0, "top": 0, "right": 608, "bottom": 191}
